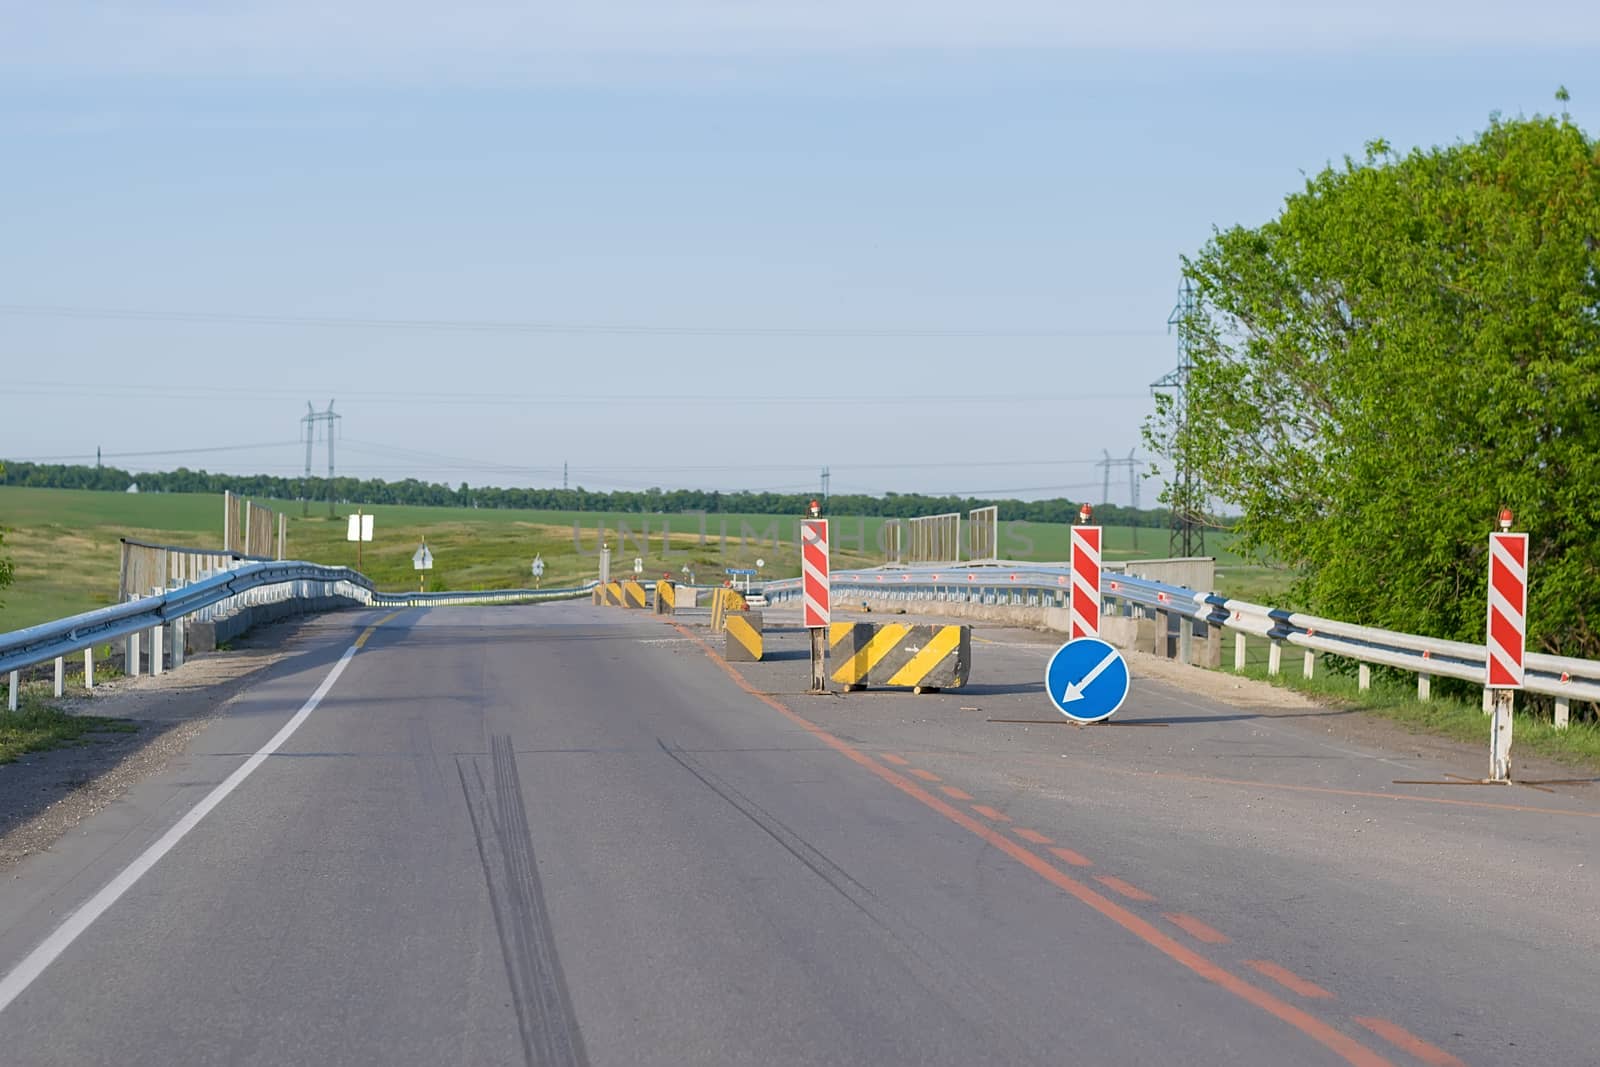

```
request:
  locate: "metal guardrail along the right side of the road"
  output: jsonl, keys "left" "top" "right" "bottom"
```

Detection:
{"left": 763, "top": 565, "right": 1600, "bottom": 725}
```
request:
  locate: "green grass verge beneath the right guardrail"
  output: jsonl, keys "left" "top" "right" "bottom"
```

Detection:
{"left": 1224, "top": 655, "right": 1600, "bottom": 771}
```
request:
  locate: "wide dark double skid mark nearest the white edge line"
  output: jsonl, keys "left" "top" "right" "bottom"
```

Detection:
{"left": 456, "top": 734, "right": 589, "bottom": 1067}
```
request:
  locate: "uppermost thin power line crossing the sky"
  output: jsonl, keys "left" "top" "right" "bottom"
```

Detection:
{"left": 0, "top": 304, "right": 1157, "bottom": 339}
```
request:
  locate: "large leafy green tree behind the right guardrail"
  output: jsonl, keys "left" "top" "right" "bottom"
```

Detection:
{"left": 1146, "top": 108, "right": 1600, "bottom": 656}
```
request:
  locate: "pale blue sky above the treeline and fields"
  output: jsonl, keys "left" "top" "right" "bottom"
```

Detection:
{"left": 0, "top": 0, "right": 1600, "bottom": 502}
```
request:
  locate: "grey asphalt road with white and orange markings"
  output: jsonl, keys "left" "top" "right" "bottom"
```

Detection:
{"left": 0, "top": 605, "right": 1600, "bottom": 1067}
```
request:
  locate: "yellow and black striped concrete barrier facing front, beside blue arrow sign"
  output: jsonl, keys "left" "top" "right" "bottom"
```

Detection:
{"left": 827, "top": 622, "right": 973, "bottom": 693}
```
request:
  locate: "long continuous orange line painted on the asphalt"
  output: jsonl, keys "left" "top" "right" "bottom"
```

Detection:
{"left": 672, "top": 622, "right": 1395, "bottom": 1067}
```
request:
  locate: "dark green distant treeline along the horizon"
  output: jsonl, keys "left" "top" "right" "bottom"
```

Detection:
{"left": 0, "top": 461, "right": 1168, "bottom": 528}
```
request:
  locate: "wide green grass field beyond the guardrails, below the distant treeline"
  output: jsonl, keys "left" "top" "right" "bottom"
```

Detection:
{"left": 0, "top": 486, "right": 1286, "bottom": 632}
